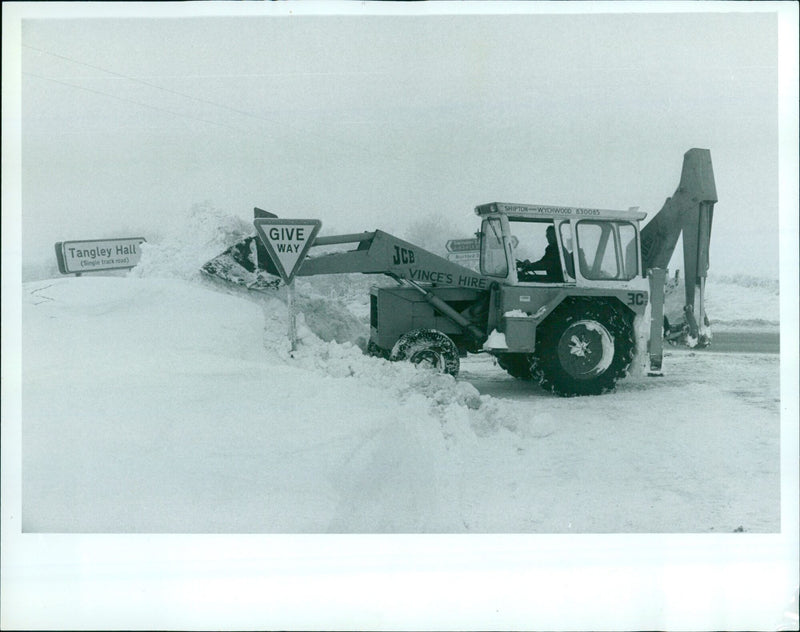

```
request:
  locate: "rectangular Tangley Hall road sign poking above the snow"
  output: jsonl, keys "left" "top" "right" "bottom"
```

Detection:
{"left": 55, "top": 237, "right": 145, "bottom": 274}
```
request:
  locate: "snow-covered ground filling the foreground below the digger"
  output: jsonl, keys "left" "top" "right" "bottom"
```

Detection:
{"left": 22, "top": 269, "right": 781, "bottom": 533}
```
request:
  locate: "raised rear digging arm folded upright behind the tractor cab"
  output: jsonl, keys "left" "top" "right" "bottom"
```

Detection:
{"left": 641, "top": 149, "right": 717, "bottom": 343}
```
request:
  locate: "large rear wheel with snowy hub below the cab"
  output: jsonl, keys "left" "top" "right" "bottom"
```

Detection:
{"left": 532, "top": 299, "right": 635, "bottom": 397}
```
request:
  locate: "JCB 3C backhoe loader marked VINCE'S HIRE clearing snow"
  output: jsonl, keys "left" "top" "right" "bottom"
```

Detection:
{"left": 204, "top": 149, "right": 717, "bottom": 395}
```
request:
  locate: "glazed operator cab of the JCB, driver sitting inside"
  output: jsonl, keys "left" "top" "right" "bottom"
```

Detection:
{"left": 475, "top": 202, "right": 646, "bottom": 285}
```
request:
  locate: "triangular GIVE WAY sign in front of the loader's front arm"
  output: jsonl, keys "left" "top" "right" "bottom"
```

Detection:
{"left": 253, "top": 218, "right": 322, "bottom": 284}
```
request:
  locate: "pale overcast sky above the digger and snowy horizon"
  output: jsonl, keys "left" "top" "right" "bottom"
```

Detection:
{"left": 4, "top": 3, "right": 792, "bottom": 276}
